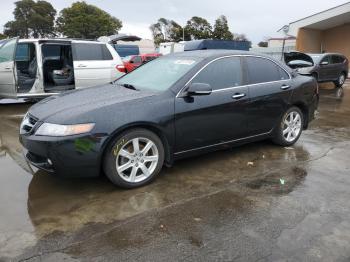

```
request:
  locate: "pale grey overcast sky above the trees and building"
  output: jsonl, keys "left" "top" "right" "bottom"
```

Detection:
{"left": 0, "top": 0, "right": 347, "bottom": 44}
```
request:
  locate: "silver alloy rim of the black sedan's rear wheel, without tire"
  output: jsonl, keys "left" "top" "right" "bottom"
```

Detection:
{"left": 282, "top": 111, "right": 301, "bottom": 142}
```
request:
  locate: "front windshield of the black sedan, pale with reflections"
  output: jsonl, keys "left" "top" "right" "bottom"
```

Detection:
{"left": 116, "top": 57, "right": 199, "bottom": 91}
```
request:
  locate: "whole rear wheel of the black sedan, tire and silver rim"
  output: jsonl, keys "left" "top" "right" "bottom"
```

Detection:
{"left": 272, "top": 106, "right": 304, "bottom": 146}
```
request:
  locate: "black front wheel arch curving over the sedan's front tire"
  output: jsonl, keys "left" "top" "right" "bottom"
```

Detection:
{"left": 100, "top": 122, "right": 173, "bottom": 167}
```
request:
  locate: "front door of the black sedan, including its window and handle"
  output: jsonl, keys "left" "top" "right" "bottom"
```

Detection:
{"left": 175, "top": 57, "right": 249, "bottom": 153}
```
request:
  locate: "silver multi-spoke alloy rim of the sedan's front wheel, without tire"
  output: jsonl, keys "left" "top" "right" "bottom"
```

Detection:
{"left": 116, "top": 137, "right": 159, "bottom": 183}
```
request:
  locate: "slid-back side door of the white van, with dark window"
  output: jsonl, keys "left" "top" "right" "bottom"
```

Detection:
{"left": 72, "top": 42, "right": 116, "bottom": 88}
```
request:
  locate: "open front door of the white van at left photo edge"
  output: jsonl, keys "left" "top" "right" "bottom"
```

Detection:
{"left": 0, "top": 37, "right": 18, "bottom": 99}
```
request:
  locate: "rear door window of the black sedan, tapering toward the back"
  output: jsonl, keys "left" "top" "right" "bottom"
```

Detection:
{"left": 246, "top": 57, "right": 289, "bottom": 84}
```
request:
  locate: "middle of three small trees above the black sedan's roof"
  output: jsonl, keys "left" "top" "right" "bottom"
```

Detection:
{"left": 185, "top": 16, "right": 212, "bottom": 40}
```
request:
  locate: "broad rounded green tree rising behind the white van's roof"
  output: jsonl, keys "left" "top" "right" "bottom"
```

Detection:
{"left": 56, "top": 2, "right": 122, "bottom": 39}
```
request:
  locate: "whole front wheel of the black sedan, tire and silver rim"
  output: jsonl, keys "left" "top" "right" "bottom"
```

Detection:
{"left": 103, "top": 128, "right": 164, "bottom": 188}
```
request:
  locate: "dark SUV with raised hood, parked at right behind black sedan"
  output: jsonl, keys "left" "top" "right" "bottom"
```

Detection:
{"left": 284, "top": 52, "right": 349, "bottom": 87}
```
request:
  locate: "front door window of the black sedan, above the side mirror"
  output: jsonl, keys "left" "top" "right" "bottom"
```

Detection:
{"left": 192, "top": 57, "right": 242, "bottom": 90}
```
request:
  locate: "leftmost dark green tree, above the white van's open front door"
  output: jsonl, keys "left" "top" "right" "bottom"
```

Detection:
{"left": 4, "top": 0, "right": 56, "bottom": 38}
